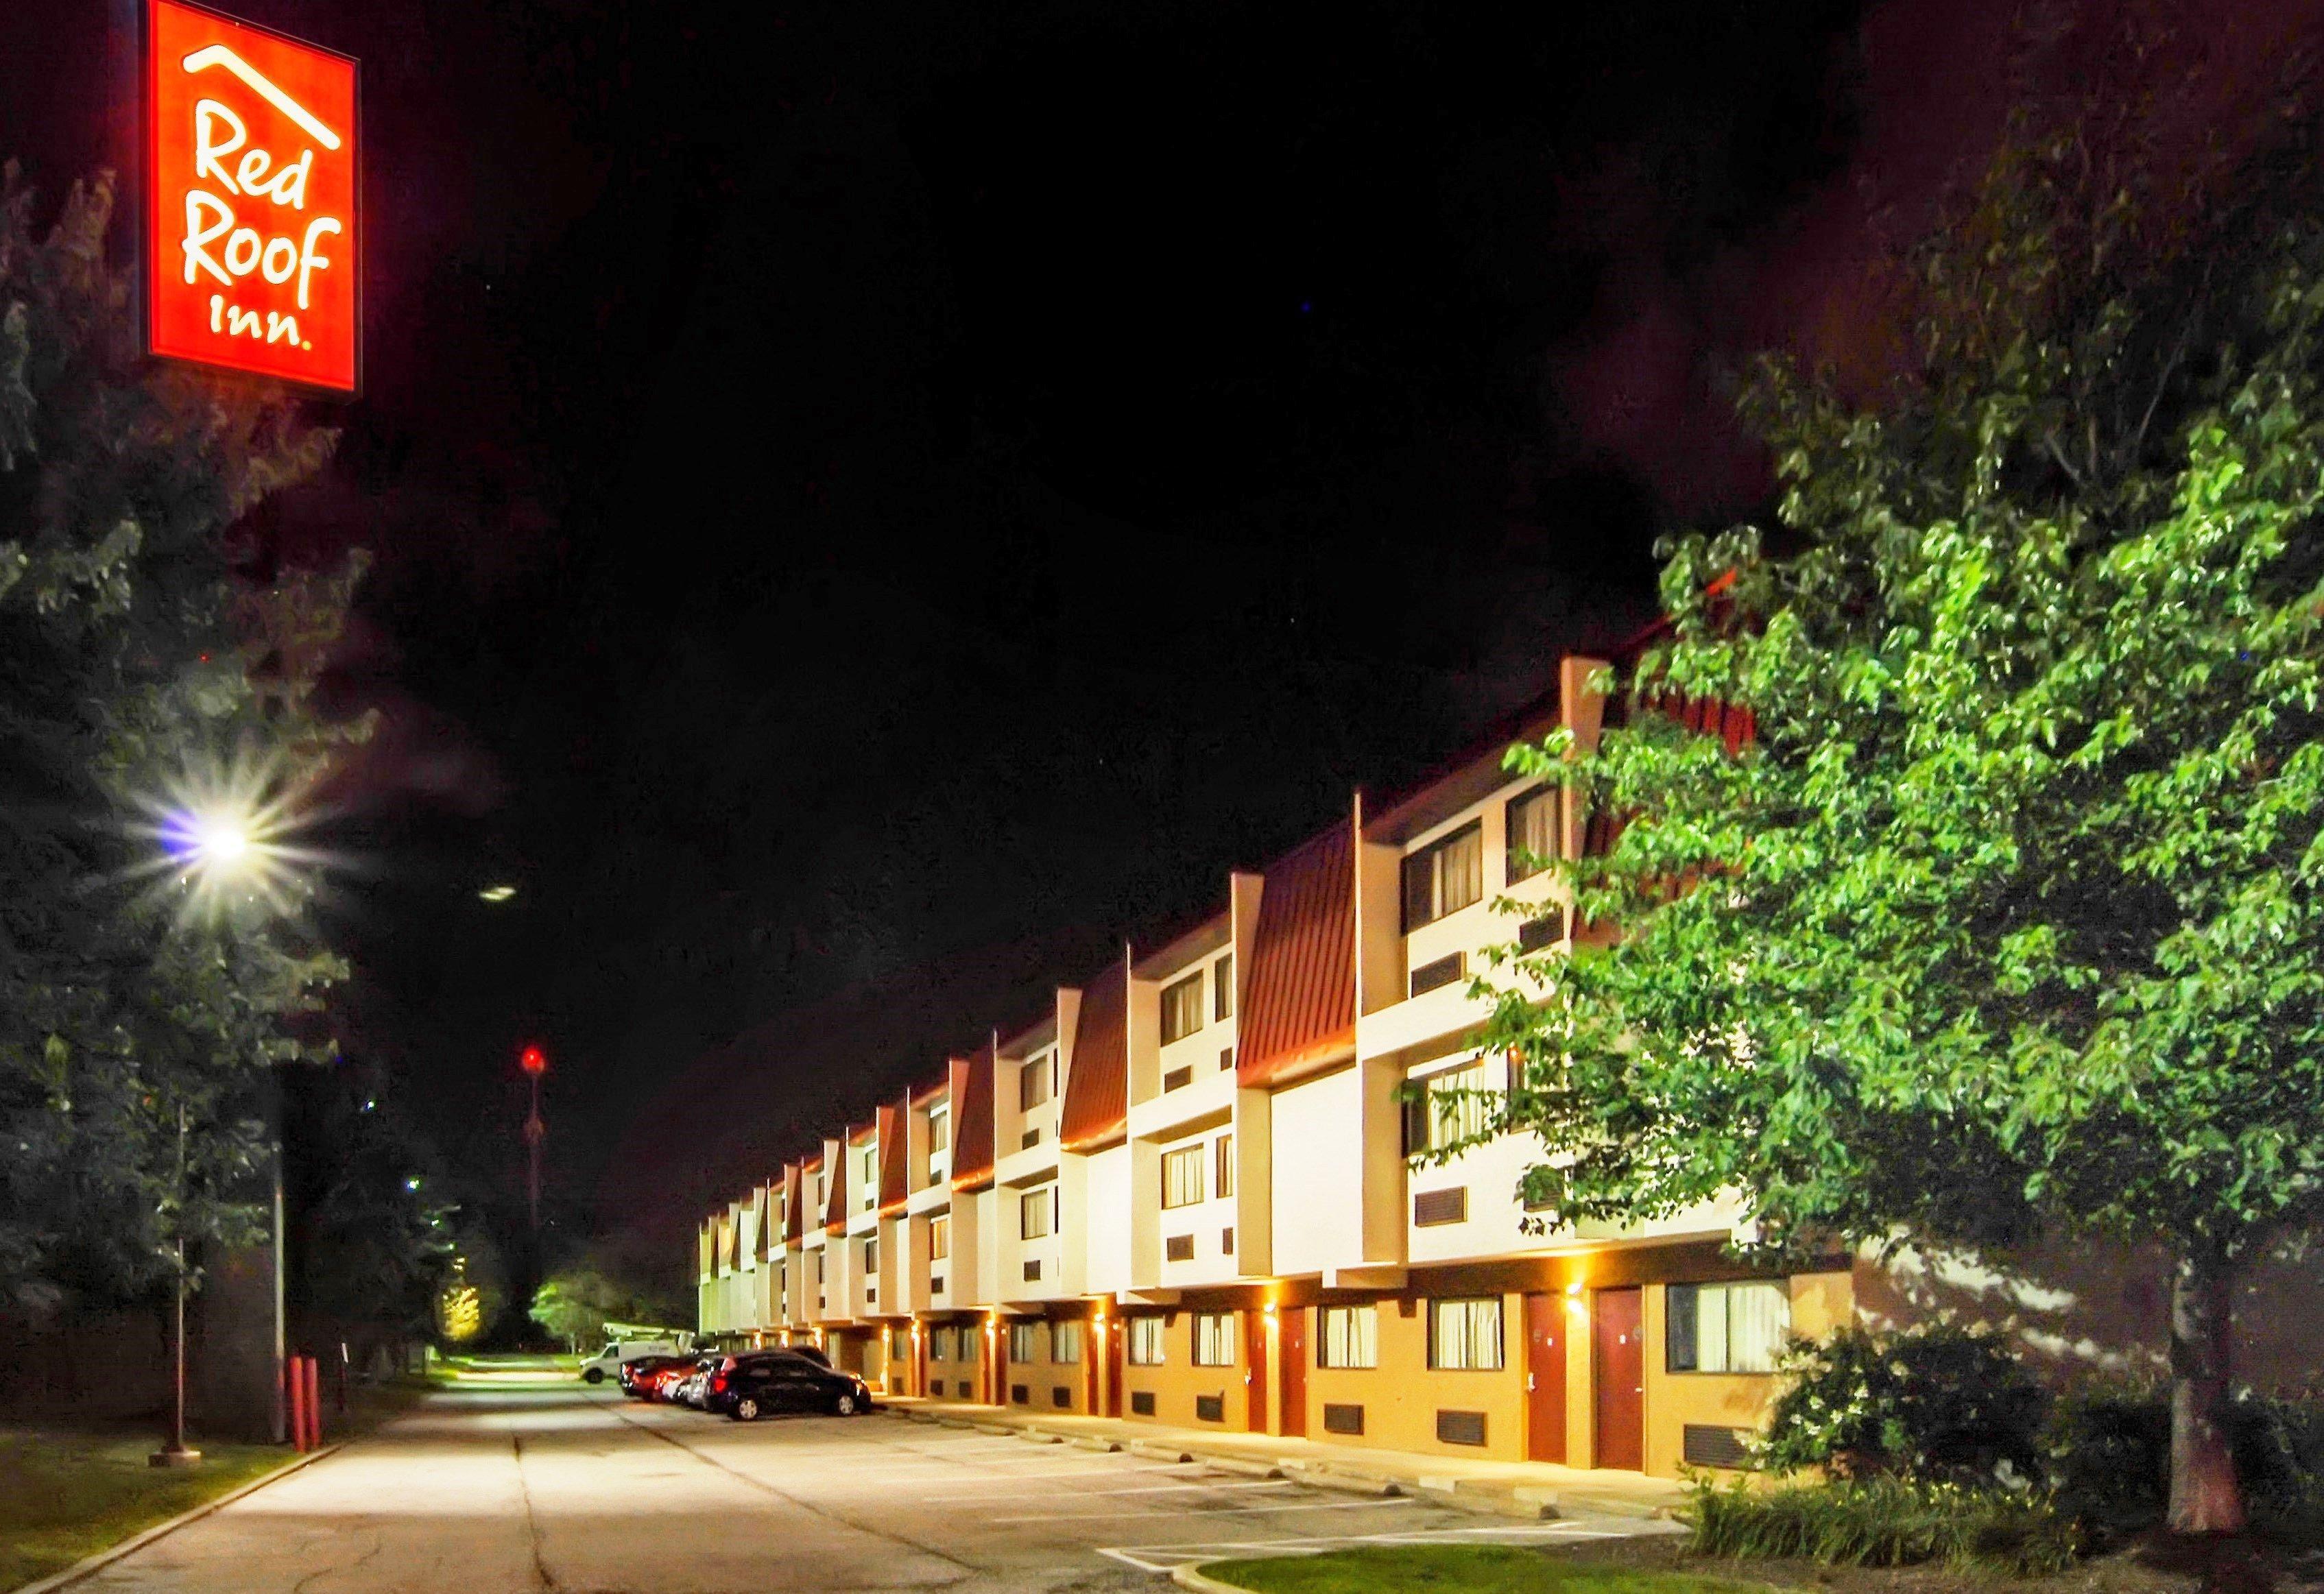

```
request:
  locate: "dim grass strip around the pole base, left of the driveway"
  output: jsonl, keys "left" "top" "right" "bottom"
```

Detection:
{"left": 0, "top": 1429, "right": 291, "bottom": 1589}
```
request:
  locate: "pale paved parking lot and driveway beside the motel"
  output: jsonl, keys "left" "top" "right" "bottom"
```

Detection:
{"left": 68, "top": 1387, "right": 1662, "bottom": 1594}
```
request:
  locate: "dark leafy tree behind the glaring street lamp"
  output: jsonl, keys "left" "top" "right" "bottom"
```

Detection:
{"left": 0, "top": 165, "right": 360, "bottom": 1306}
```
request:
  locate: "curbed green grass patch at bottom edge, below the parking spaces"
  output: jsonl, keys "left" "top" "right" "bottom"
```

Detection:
{"left": 1201, "top": 1545, "right": 1766, "bottom": 1594}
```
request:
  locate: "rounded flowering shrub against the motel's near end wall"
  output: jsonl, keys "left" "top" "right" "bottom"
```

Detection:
{"left": 1757, "top": 1322, "right": 2048, "bottom": 1482}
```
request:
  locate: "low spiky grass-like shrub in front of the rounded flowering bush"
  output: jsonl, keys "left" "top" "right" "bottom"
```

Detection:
{"left": 1687, "top": 1478, "right": 2083, "bottom": 1575}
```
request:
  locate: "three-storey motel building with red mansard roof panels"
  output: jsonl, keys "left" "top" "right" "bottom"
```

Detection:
{"left": 697, "top": 657, "right": 2286, "bottom": 1478}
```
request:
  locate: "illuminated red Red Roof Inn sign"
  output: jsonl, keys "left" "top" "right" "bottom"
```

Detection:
{"left": 147, "top": 0, "right": 363, "bottom": 393}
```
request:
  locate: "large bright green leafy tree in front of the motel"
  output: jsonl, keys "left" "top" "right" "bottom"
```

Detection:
{"left": 1492, "top": 123, "right": 2324, "bottom": 1531}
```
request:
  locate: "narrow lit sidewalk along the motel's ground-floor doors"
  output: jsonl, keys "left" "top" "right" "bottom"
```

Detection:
{"left": 881, "top": 1394, "right": 1685, "bottom": 1520}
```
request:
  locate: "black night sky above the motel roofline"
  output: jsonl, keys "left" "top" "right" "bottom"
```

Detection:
{"left": 13, "top": 0, "right": 2314, "bottom": 1273}
